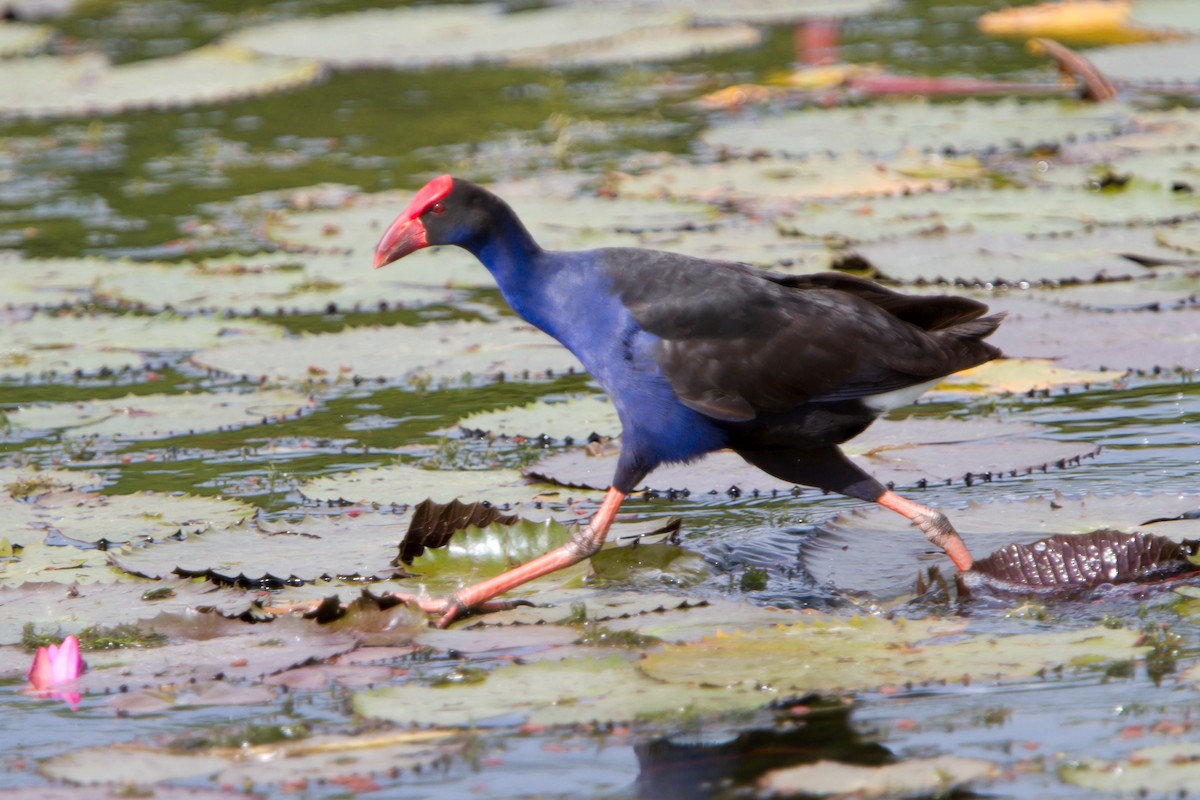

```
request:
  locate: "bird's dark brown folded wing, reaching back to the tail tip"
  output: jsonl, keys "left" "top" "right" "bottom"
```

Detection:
{"left": 605, "top": 249, "right": 998, "bottom": 421}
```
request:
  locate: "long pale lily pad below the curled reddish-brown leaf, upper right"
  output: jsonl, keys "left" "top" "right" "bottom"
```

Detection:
{"left": 702, "top": 100, "right": 1134, "bottom": 156}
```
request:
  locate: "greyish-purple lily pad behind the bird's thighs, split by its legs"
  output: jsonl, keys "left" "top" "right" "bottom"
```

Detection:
{"left": 526, "top": 419, "right": 1097, "bottom": 495}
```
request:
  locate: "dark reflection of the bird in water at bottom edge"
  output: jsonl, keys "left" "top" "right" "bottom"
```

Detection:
{"left": 634, "top": 698, "right": 894, "bottom": 800}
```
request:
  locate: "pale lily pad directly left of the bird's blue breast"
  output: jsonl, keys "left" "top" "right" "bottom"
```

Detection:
{"left": 192, "top": 321, "right": 582, "bottom": 385}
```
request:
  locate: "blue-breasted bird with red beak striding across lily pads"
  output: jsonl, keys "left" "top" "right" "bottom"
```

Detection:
{"left": 374, "top": 175, "right": 1003, "bottom": 627}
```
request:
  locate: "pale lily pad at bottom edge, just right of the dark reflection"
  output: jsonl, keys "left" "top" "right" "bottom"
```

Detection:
{"left": 758, "top": 756, "right": 1000, "bottom": 798}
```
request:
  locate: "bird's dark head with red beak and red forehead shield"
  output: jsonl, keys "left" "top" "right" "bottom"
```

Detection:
{"left": 374, "top": 175, "right": 493, "bottom": 269}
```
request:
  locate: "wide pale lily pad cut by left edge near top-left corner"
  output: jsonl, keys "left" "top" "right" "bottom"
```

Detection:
{"left": 0, "top": 44, "right": 324, "bottom": 116}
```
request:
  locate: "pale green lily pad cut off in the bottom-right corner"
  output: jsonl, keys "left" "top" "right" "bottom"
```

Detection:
{"left": 1060, "top": 741, "right": 1200, "bottom": 795}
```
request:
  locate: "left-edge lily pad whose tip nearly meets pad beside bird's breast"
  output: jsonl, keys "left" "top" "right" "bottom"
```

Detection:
{"left": 0, "top": 313, "right": 283, "bottom": 378}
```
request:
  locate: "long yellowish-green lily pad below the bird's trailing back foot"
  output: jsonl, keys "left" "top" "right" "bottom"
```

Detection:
{"left": 638, "top": 616, "right": 1144, "bottom": 697}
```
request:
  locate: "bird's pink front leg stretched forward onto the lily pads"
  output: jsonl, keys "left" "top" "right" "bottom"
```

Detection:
{"left": 397, "top": 488, "right": 625, "bottom": 627}
